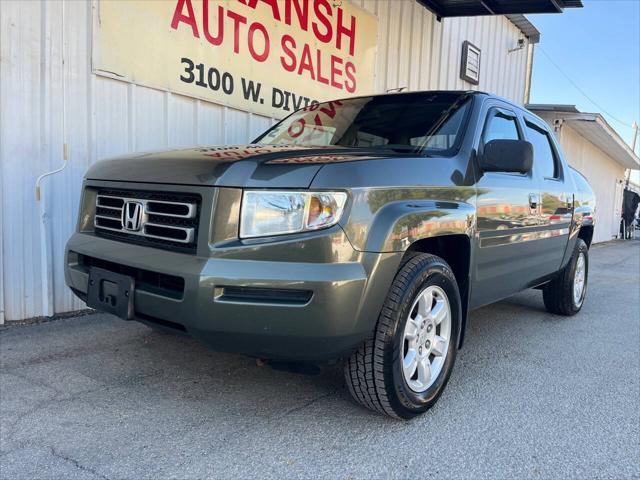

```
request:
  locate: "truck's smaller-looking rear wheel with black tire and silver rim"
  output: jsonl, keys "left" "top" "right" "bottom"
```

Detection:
{"left": 542, "top": 238, "right": 589, "bottom": 316}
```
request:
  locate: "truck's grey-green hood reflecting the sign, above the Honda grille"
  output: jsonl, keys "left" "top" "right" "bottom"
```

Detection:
{"left": 86, "top": 145, "right": 388, "bottom": 188}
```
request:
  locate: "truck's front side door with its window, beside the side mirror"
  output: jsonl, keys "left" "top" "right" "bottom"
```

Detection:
{"left": 471, "top": 100, "right": 540, "bottom": 308}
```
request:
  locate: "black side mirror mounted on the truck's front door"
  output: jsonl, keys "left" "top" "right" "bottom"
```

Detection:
{"left": 480, "top": 140, "right": 533, "bottom": 173}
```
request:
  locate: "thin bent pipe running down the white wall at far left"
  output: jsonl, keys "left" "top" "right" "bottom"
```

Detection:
{"left": 35, "top": 0, "right": 68, "bottom": 317}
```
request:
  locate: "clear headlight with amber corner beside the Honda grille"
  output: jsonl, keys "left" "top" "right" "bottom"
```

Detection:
{"left": 240, "top": 190, "right": 347, "bottom": 238}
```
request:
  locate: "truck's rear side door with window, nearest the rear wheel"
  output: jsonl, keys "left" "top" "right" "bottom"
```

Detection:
{"left": 524, "top": 115, "right": 573, "bottom": 275}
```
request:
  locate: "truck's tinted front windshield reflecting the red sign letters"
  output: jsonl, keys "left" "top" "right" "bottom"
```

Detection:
{"left": 254, "top": 92, "right": 471, "bottom": 155}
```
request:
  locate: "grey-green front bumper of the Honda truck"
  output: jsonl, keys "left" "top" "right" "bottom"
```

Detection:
{"left": 65, "top": 232, "right": 400, "bottom": 361}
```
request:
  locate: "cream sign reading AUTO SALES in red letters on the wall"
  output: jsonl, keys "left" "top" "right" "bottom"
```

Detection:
{"left": 93, "top": 0, "right": 378, "bottom": 117}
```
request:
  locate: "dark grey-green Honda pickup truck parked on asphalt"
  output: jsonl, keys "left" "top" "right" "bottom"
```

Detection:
{"left": 65, "top": 91, "right": 595, "bottom": 418}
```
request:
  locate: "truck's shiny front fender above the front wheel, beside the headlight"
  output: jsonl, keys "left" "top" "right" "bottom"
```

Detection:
{"left": 345, "top": 200, "right": 475, "bottom": 252}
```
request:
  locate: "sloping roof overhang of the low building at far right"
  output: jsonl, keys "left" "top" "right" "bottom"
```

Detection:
{"left": 527, "top": 105, "right": 640, "bottom": 170}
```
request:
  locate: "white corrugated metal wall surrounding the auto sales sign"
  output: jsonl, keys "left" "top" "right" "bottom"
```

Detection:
{"left": 0, "top": 0, "right": 527, "bottom": 323}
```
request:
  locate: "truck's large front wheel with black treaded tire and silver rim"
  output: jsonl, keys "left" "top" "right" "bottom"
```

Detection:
{"left": 344, "top": 254, "right": 462, "bottom": 419}
